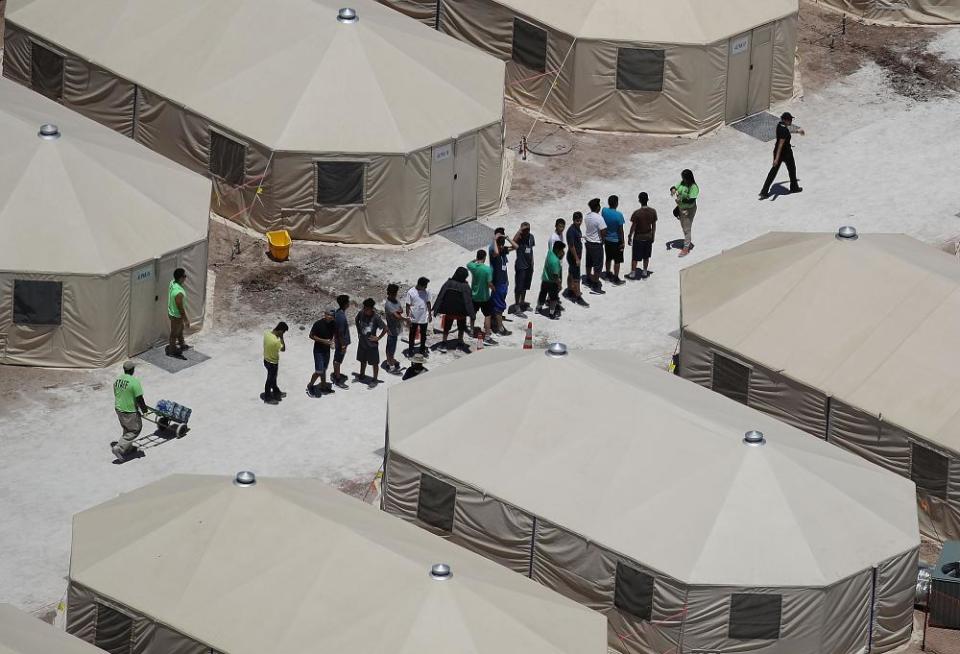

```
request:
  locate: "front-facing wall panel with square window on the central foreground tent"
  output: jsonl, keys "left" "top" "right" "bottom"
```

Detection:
{"left": 682, "top": 586, "right": 824, "bottom": 654}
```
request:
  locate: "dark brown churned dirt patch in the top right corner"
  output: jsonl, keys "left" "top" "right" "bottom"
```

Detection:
{"left": 798, "top": 2, "right": 960, "bottom": 102}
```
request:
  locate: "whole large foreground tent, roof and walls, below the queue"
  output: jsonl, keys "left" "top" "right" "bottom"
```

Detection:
{"left": 383, "top": 350, "right": 919, "bottom": 654}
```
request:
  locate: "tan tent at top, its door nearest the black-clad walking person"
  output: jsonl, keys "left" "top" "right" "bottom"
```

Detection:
{"left": 382, "top": 0, "right": 798, "bottom": 134}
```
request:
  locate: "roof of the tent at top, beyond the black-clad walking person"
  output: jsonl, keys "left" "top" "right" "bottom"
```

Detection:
{"left": 488, "top": 0, "right": 799, "bottom": 44}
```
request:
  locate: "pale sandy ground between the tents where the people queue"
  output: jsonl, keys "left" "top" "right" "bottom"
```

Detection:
{"left": 0, "top": 6, "right": 960, "bottom": 652}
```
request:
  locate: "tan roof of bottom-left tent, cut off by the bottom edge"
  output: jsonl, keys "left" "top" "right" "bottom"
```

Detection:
{"left": 70, "top": 475, "right": 606, "bottom": 654}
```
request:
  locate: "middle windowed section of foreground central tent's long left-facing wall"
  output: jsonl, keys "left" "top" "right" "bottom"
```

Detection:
{"left": 532, "top": 519, "right": 686, "bottom": 654}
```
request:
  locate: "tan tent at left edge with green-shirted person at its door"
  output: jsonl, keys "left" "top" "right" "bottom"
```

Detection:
{"left": 0, "top": 80, "right": 210, "bottom": 367}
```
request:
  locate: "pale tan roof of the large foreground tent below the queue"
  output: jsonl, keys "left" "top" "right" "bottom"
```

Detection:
{"left": 389, "top": 350, "right": 919, "bottom": 586}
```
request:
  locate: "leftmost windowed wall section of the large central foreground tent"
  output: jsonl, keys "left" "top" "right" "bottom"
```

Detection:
{"left": 383, "top": 455, "right": 533, "bottom": 575}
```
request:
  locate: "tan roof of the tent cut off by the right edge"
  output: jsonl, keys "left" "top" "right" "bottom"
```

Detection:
{"left": 681, "top": 233, "right": 960, "bottom": 450}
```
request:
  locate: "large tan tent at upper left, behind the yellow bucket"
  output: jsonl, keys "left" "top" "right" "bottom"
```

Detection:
{"left": 3, "top": 0, "right": 504, "bottom": 244}
